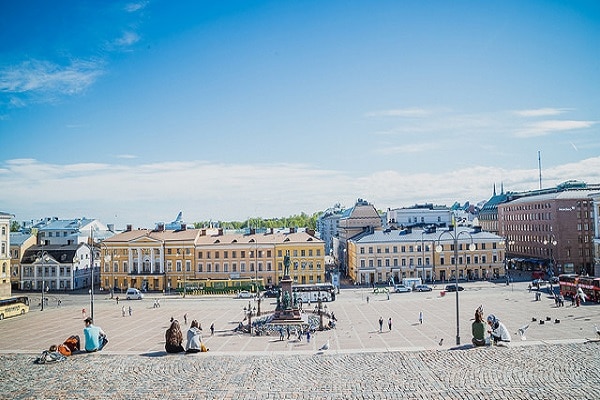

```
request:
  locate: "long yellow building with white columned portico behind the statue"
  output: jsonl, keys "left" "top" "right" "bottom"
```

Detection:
{"left": 101, "top": 229, "right": 325, "bottom": 292}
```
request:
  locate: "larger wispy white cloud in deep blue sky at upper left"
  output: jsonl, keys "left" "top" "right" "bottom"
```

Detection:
{"left": 0, "top": 60, "right": 104, "bottom": 106}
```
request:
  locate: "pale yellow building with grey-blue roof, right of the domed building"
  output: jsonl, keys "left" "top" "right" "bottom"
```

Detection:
{"left": 348, "top": 227, "right": 506, "bottom": 284}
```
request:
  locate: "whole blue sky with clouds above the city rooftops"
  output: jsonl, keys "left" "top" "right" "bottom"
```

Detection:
{"left": 0, "top": 0, "right": 600, "bottom": 227}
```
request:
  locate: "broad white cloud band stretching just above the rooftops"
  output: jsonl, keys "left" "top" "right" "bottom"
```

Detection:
{"left": 0, "top": 157, "right": 600, "bottom": 228}
